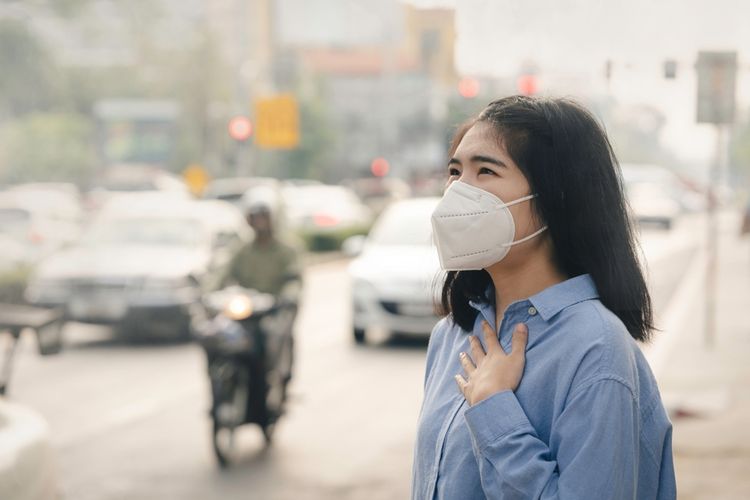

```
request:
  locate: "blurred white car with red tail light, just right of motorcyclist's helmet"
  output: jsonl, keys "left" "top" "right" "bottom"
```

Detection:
{"left": 282, "top": 184, "right": 373, "bottom": 250}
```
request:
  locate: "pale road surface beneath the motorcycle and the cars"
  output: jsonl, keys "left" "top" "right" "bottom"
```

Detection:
{"left": 11, "top": 216, "right": 703, "bottom": 500}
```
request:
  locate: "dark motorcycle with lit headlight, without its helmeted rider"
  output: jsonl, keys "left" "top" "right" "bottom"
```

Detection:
{"left": 191, "top": 286, "right": 297, "bottom": 467}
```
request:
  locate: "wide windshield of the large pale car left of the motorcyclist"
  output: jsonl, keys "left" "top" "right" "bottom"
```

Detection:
{"left": 83, "top": 217, "right": 203, "bottom": 247}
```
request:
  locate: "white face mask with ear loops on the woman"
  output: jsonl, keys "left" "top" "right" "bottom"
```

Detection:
{"left": 432, "top": 181, "right": 547, "bottom": 271}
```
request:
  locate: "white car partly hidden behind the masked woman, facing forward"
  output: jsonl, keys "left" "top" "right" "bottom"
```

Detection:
{"left": 345, "top": 197, "right": 441, "bottom": 343}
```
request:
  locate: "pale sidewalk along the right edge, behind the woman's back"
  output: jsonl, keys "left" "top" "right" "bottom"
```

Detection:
{"left": 657, "top": 212, "right": 750, "bottom": 500}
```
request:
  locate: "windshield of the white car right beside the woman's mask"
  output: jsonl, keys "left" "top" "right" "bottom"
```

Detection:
{"left": 368, "top": 199, "right": 435, "bottom": 246}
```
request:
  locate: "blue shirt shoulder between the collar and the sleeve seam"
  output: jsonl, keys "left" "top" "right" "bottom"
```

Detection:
{"left": 554, "top": 300, "right": 639, "bottom": 396}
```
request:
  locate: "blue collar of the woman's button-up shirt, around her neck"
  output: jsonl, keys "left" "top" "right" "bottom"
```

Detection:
{"left": 469, "top": 274, "right": 599, "bottom": 321}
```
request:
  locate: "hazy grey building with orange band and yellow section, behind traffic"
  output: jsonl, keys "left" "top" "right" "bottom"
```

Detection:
{"left": 278, "top": 0, "right": 458, "bottom": 178}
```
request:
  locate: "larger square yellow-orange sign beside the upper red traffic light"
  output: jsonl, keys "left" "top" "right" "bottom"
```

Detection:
{"left": 255, "top": 94, "right": 299, "bottom": 149}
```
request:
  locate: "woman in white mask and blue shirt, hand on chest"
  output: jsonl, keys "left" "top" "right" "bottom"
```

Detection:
{"left": 412, "top": 96, "right": 676, "bottom": 500}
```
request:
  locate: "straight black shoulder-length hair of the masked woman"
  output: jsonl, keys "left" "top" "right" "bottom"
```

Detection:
{"left": 440, "top": 96, "right": 654, "bottom": 341}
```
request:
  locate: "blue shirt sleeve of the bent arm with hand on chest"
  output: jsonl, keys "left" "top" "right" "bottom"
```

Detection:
{"left": 465, "top": 377, "right": 639, "bottom": 500}
